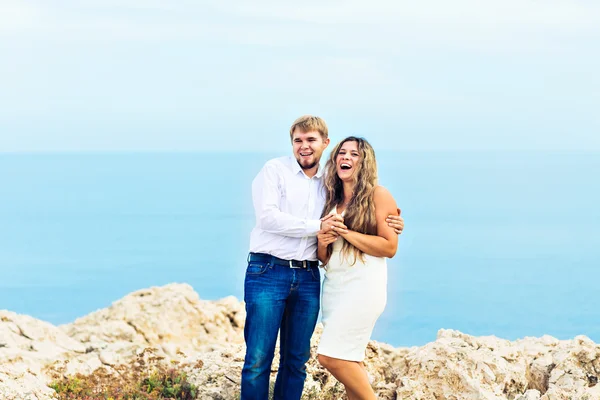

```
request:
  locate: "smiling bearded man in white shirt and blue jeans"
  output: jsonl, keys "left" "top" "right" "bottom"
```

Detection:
{"left": 241, "top": 115, "right": 404, "bottom": 400}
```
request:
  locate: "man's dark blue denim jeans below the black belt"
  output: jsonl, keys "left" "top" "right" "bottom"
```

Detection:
{"left": 241, "top": 255, "right": 321, "bottom": 400}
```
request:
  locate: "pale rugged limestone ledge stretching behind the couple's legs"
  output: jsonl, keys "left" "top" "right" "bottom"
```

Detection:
{"left": 0, "top": 284, "right": 600, "bottom": 400}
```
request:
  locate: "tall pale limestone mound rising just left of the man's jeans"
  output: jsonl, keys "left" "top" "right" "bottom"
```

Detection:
{"left": 61, "top": 284, "right": 245, "bottom": 355}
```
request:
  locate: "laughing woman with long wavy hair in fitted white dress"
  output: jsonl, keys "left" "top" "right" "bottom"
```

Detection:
{"left": 317, "top": 136, "right": 398, "bottom": 400}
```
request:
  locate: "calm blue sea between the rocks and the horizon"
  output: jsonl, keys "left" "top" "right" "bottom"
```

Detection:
{"left": 0, "top": 153, "right": 600, "bottom": 346}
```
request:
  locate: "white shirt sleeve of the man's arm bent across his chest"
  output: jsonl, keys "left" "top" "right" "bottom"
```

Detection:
{"left": 252, "top": 163, "right": 321, "bottom": 237}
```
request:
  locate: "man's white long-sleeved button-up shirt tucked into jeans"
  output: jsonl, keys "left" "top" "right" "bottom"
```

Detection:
{"left": 250, "top": 156, "right": 325, "bottom": 260}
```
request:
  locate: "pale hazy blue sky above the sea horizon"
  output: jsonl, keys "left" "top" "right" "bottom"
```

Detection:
{"left": 0, "top": 0, "right": 600, "bottom": 152}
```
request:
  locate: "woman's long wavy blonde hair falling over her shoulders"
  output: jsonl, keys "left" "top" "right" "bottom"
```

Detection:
{"left": 321, "top": 136, "right": 377, "bottom": 265}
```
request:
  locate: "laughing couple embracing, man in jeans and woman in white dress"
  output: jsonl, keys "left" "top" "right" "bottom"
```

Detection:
{"left": 241, "top": 115, "right": 404, "bottom": 400}
